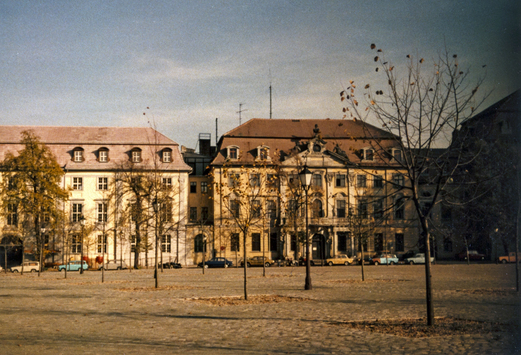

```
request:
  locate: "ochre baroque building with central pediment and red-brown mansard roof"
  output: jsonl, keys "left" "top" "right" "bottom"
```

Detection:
{"left": 204, "top": 119, "right": 419, "bottom": 263}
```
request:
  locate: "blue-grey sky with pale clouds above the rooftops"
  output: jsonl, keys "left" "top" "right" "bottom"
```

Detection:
{"left": 0, "top": 0, "right": 521, "bottom": 147}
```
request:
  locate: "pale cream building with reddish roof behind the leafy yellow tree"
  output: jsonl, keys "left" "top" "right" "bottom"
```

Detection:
{"left": 0, "top": 126, "right": 192, "bottom": 266}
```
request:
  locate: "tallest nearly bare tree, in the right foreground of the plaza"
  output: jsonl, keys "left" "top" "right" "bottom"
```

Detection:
{"left": 340, "top": 44, "right": 483, "bottom": 325}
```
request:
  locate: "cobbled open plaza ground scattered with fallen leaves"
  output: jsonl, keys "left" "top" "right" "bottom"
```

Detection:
{"left": 0, "top": 263, "right": 521, "bottom": 355}
